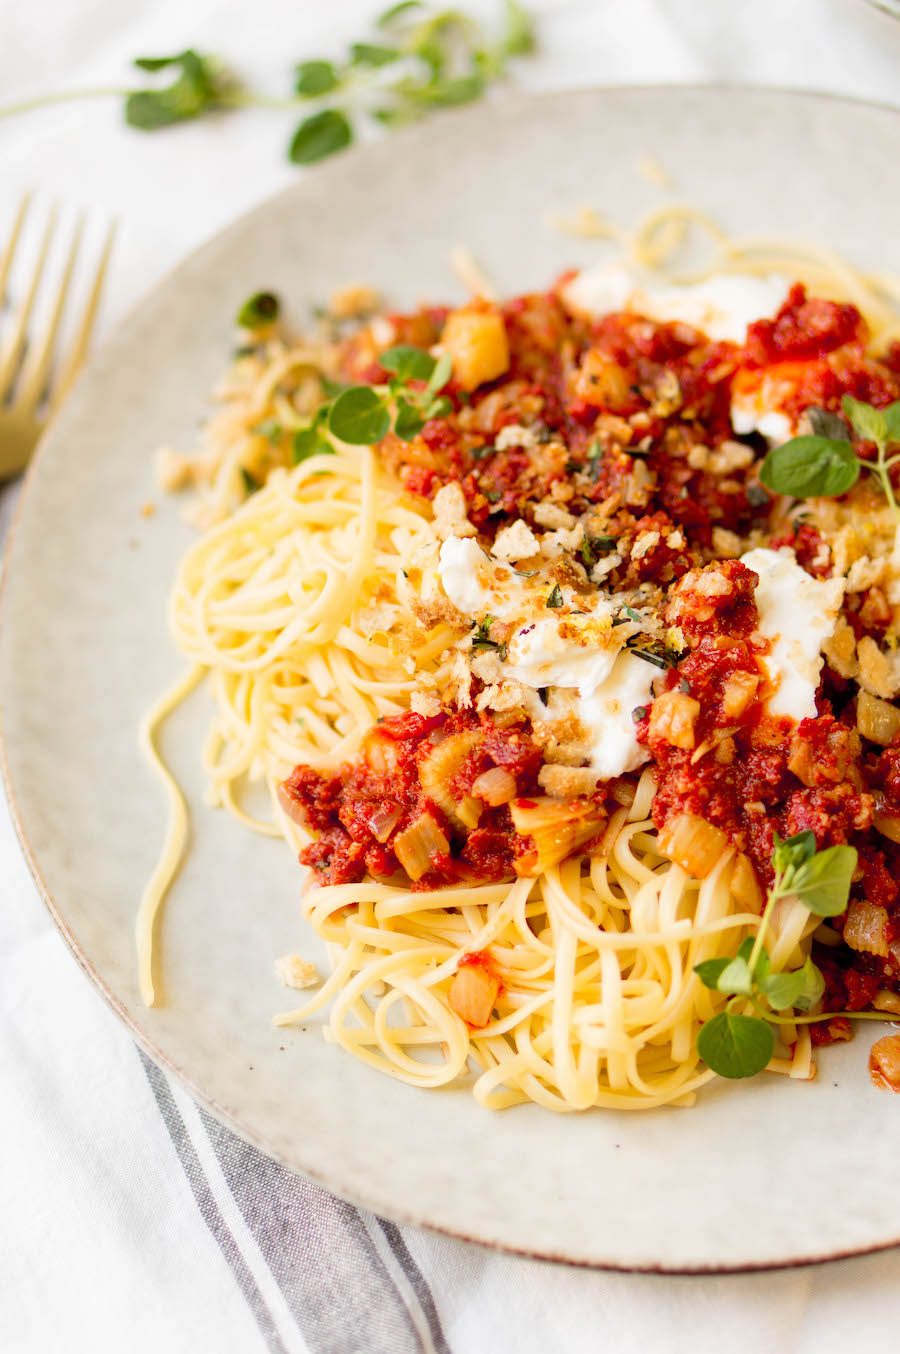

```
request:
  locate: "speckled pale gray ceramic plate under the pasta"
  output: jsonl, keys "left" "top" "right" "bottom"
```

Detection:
{"left": 0, "top": 88, "right": 900, "bottom": 1270}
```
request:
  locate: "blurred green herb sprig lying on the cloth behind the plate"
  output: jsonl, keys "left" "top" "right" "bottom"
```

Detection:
{"left": 0, "top": 0, "right": 536, "bottom": 164}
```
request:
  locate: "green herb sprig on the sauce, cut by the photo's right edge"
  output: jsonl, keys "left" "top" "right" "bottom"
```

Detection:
{"left": 759, "top": 395, "right": 900, "bottom": 517}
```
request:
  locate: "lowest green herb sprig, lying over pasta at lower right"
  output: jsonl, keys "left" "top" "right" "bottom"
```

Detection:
{"left": 694, "top": 831, "right": 857, "bottom": 1078}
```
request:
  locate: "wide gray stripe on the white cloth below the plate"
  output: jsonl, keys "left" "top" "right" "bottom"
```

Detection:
{"left": 202, "top": 1112, "right": 447, "bottom": 1354}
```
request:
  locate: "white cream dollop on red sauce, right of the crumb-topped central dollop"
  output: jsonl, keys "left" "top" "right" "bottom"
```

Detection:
{"left": 740, "top": 548, "right": 845, "bottom": 720}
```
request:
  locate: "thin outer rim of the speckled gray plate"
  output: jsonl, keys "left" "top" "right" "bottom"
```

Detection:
{"left": 0, "top": 81, "right": 900, "bottom": 1277}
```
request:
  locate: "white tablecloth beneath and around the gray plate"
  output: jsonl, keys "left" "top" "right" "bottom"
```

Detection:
{"left": 0, "top": 0, "right": 900, "bottom": 1354}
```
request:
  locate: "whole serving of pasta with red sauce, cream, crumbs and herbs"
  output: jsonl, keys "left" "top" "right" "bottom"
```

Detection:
{"left": 138, "top": 213, "right": 900, "bottom": 1110}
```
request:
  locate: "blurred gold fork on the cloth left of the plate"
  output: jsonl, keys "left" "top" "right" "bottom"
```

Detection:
{"left": 0, "top": 194, "right": 115, "bottom": 479}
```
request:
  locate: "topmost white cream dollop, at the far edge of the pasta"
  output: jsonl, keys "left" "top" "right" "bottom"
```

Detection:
{"left": 562, "top": 263, "right": 788, "bottom": 343}
